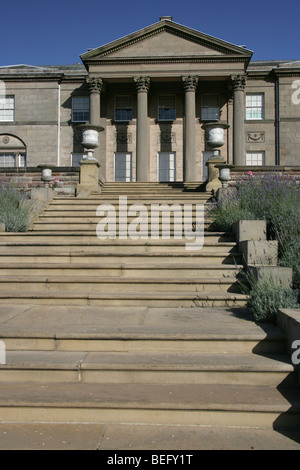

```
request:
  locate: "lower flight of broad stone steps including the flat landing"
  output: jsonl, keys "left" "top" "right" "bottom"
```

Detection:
{"left": 0, "top": 305, "right": 300, "bottom": 429}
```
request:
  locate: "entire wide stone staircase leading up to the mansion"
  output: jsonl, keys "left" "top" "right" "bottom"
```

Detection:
{"left": 0, "top": 183, "right": 300, "bottom": 436}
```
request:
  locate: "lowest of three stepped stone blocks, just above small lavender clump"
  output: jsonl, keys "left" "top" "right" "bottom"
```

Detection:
{"left": 248, "top": 266, "right": 293, "bottom": 289}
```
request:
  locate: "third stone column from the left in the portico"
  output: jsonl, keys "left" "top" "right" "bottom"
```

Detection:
{"left": 182, "top": 75, "right": 198, "bottom": 182}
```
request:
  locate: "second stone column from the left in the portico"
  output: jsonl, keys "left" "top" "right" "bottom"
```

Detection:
{"left": 134, "top": 77, "right": 150, "bottom": 181}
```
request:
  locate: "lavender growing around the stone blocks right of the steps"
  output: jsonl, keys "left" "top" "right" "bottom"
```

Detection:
{"left": 210, "top": 172, "right": 300, "bottom": 316}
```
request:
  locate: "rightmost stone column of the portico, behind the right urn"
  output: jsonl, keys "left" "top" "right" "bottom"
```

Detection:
{"left": 231, "top": 75, "right": 246, "bottom": 166}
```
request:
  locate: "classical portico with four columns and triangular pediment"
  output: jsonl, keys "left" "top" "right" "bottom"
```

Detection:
{"left": 81, "top": 18, "right": 252, "bottom": 182}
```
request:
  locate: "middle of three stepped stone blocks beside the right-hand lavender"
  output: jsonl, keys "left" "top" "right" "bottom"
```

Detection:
{"left": 239, "top": 240, "right": 278, "bottom": 266}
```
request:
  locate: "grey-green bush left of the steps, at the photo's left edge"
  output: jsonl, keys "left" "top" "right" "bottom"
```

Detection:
{"left": 0, "top": 186, "right": 29, "bottom": 232}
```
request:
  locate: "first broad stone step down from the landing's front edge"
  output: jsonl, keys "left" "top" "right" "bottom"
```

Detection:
{"left": 0, "top": 350, "right": 295, "bottom": 386}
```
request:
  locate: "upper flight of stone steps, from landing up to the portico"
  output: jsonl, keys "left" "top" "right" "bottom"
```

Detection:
{"left": 0, "top": 184, "right": 246, "bottom": 307}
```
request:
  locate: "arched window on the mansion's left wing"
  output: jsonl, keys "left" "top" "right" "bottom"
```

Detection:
{"left": 0, "top": 134, "right": 26, "bottom": 168}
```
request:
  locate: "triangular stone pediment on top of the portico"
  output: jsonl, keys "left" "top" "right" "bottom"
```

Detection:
{"left": 81, "top": 20, "right": 252, "bottom": 62}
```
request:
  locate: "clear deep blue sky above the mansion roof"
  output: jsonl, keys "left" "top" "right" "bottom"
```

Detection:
{"left": 0, "top": 0, "right": 300, "bottom": 65}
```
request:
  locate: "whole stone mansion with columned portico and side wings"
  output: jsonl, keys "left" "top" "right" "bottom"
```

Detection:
{"left": 0, "top": 17, "right": 300, "bottom": 182}
